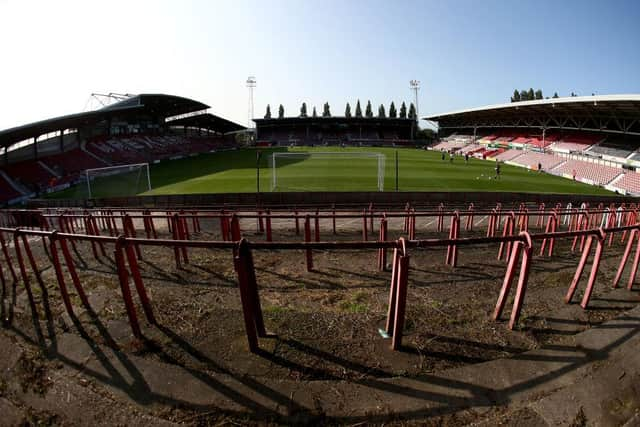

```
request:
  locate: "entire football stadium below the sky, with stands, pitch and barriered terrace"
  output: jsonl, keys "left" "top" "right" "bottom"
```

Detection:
{"left": 0, "top": 87, "right": 640, "bottom": 424}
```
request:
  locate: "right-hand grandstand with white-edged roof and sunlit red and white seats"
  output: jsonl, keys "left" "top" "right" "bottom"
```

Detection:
{"left": 425, "top": 95, "right": 640, "bottom": 194}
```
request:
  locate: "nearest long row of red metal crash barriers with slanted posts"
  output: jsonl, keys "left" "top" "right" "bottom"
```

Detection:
{"left": 0, "top": 221, "right": 640, "bottom": 352}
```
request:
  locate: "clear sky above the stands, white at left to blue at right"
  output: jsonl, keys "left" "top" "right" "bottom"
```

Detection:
{"left": 0, "top": 0, "right": 640, "bottom": 129}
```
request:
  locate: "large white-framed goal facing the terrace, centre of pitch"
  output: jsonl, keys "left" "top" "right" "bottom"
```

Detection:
{"left": 270, "top": 152, "right": 385, "bottom": 191}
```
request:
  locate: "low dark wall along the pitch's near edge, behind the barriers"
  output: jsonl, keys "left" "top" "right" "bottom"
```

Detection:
{"left": 28, "top": 192, "right": 637, "bottom": 208}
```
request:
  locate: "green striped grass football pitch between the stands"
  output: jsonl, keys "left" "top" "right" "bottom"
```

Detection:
{"left": 49, "top": 147, "right": 612, "bottom": 199}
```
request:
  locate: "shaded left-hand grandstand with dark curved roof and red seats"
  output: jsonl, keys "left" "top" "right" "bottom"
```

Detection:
{"left": 0, "top": 94, "right": 245, "bottom": 204}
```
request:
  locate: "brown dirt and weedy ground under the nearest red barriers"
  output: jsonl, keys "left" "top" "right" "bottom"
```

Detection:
{"left": 0, "top": 209, "right": 637, "bottom": 425}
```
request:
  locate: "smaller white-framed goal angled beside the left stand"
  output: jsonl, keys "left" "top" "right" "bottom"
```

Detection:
{"left": 85, "top": 163, "right": 151, "bottom": 198}
